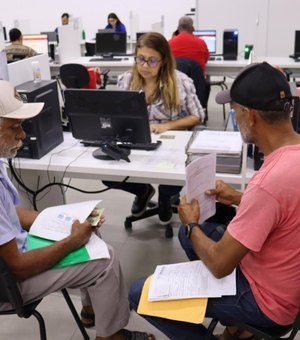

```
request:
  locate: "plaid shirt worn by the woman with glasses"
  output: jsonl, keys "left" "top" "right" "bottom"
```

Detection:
{"left": 118, "top": 70, "right": 204, "bottom": 124}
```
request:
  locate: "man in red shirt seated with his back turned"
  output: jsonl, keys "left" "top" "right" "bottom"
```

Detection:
{"left": 169, "top": 16, "right": 209, "bottom": 74}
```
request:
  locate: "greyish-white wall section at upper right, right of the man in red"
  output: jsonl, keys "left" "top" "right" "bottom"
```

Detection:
{"left": 196, "top": 0, "right": 300, "bottom": 57}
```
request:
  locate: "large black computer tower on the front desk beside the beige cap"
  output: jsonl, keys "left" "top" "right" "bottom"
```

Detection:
{"left": 16, "top": 80, "right": 63, "bottom": 159}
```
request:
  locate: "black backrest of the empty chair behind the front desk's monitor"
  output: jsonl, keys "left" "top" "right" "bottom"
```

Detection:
{"left": 60, "top": 64, "right": 90, "bottom": 89}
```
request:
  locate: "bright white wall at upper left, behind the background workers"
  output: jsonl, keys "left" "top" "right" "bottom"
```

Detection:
{"left": 0, "top": 0, "right": 195, "bottom": 39}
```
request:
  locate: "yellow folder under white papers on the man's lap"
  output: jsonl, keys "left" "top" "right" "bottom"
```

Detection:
{"left": 137, "top": 275, "right": 207, "bottom": 324}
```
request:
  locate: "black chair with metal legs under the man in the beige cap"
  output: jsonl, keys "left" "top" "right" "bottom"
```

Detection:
{"left": 0, "top": 257, "right": 89, "bottom": 340}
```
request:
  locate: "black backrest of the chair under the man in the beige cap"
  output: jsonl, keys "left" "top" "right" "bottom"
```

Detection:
{"left": 0, "top": 257, "right": 23, "bottom": 317}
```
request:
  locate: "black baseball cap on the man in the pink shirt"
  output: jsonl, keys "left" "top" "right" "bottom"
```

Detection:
{"left": 216, "top": 62, "right": 292, "bottom": 111}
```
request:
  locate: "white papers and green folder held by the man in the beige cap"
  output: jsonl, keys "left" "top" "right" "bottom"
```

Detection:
{"left": 28, "top": 200, "right": 110, "bottom": 267}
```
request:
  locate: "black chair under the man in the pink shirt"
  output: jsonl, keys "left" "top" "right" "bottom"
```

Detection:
{"left": 205, "top": 312, "right": 300, "bottom": 340}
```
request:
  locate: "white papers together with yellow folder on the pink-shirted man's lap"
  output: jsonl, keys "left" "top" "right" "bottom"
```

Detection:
{"left": 137, "top": 260, "right": 236, "bottom": 323}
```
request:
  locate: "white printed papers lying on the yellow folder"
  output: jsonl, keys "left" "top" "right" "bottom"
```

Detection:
{"left": 148, "top": 260, "right": 236, "bottom": 301}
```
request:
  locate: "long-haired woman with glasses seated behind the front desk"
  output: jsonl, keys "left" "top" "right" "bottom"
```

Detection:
{"left": 103, "top": 33, "right": 204, "bottom": 224}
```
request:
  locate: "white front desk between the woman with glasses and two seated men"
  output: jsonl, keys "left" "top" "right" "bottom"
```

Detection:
{"left": 9, "top": 131, "right": 246, "bottom": 208}
